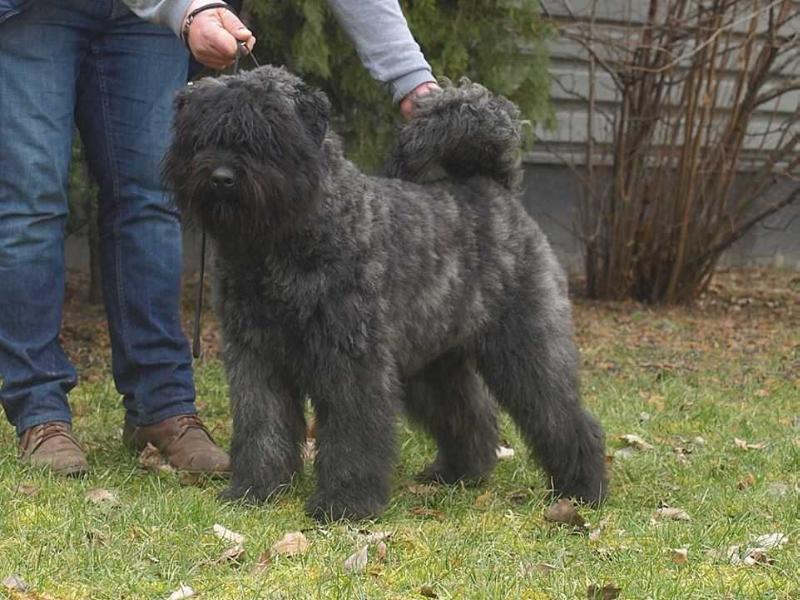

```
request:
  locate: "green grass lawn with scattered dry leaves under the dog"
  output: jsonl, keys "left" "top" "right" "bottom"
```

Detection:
{"left": 0, "top": 271, "right": 800, "bottom": 599}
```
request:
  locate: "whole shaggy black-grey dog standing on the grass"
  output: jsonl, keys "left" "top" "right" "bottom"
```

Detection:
{"left": 165, "top": 67, "right": 606, "bottom": 519}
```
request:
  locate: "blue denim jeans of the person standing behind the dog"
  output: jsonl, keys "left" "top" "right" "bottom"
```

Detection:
{"left": 0, "top": 0, "right": 195, "bottom": 434}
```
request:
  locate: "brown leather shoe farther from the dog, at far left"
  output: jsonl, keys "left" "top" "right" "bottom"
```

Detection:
{"left": 19, "top": 421, "right": 89, "bottom": 477}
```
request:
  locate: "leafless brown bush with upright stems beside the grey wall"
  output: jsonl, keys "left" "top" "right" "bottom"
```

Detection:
{"left": 544, "top": 0, "right": 800, "bottom": 304}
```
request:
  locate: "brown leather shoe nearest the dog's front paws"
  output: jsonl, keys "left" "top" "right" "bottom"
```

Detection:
{"left": 122, "top": 415, "right": 230, "bottom": 475}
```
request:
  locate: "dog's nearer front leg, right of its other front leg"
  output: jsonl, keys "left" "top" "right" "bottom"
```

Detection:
{"left": 307, "top": 365, "right": 398, "bottom": 520}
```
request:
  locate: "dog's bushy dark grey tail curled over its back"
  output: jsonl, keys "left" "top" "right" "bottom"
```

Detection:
{"left": 386, "top": 79, "right": 522, "bottom": 189}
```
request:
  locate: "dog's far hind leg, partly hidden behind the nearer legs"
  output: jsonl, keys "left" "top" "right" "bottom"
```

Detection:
{"left": 405, "top": 354, "right": 497, "bottom": 483}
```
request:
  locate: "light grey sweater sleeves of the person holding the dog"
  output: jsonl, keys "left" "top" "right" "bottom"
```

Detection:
{"left": 124, "top": 0, "right": 435, "bottom": 102}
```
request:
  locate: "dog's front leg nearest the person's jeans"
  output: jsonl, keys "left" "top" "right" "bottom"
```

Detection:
{"left": 220, "top": 344, "right": 306, "bottom": 502}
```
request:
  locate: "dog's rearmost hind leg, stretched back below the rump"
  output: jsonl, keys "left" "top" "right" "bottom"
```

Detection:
{"left": 478, "top": 288, "right": 607, "bottom": 503}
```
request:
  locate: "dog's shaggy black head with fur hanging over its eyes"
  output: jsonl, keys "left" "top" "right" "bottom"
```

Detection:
{"left": 163, "top": 66, "right": 330, "bottom": 241}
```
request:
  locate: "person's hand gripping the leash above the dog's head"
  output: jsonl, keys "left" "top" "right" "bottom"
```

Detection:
{"left": 186, "top": 0, "right": 256, "bottom": 69}
